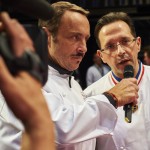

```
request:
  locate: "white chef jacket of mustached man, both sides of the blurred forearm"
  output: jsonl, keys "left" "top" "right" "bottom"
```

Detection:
{"left": 0, "top": 63, "right": 117, "bottom": 150}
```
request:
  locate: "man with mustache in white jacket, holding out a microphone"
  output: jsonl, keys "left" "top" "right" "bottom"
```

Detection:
{"left": 39, "top": 1, "right": 138, "bottom": 150}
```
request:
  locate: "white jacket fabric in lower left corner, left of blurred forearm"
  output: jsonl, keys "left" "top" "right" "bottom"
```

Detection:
{"left": 0, "top": 93, "right": 24, "bottom": 150}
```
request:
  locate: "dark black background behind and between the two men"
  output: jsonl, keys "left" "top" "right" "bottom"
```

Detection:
{"left": 1, "top": 0, "right": 150, "bottom": 89}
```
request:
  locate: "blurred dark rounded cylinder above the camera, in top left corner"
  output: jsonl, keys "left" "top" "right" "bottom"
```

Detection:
{"left": 0, "top": 0, "right": 55, "bottom": 20}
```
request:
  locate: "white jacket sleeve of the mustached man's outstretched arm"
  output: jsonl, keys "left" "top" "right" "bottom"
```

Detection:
{"left": 44, "top": 91, "right": 117, "bottom": 144}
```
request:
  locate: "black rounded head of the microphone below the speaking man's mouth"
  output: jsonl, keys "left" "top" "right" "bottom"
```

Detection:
{"left": 123, "top": 65, "right": 134, "bottom": 78}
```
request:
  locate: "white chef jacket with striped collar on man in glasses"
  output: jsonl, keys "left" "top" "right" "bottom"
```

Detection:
{"left": 84, "top": 62, "right": 150, "bottom": 150}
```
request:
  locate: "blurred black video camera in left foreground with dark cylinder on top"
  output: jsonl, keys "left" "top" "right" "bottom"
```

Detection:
{"left": 0, "top": 0, "right": 54, "bottom": 85}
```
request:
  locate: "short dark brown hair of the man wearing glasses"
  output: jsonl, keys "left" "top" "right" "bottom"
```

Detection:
{"left": 94, "top": 12, "right": 136, "bottom": 48}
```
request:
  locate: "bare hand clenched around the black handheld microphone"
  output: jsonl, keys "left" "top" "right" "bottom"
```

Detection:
{"left": 108, "top": 78, "right": 139, "bottom": 106}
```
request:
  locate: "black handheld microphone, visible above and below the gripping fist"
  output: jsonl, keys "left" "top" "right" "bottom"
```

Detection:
{"left": 123, "top": 65, "right": 134, "bottom": 123}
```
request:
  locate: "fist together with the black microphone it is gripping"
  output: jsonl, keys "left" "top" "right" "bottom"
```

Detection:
{"left": 107, "top": 66, "right": 139, "bottom": 118}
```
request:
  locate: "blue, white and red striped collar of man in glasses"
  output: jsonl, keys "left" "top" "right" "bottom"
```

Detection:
{"left": 110, "top": 62, "right": 144, "bottom": 84}
